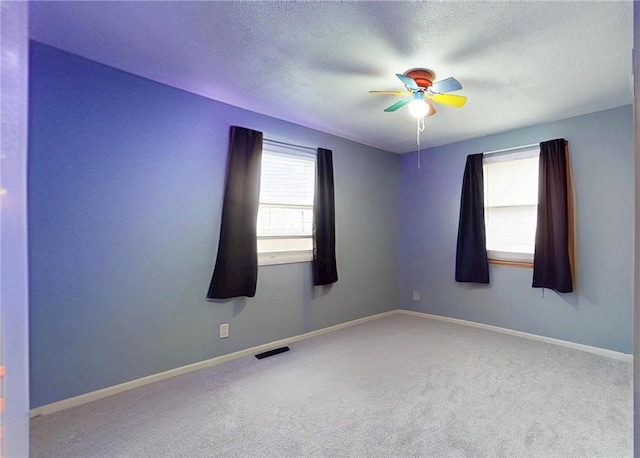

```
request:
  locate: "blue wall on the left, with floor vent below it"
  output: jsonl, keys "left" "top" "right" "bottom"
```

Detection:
{"left": 29, "top": 42, "right": 398, "bottom": 407}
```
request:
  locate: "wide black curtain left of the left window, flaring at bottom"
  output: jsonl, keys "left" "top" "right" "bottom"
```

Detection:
{"left": 207, "top": 126, "right": 262, "bottom": 299}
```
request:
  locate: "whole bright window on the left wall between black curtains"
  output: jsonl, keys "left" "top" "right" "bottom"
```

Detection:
{"left": 257, "top": 140, "right": 316, "bottom": 265}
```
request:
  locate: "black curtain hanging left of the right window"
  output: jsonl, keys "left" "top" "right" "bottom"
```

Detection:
{"left": 456, "top": 153, "right": 489, "bottom": 283}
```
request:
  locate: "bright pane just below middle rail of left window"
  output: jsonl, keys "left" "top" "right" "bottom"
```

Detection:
{"left": 258, "top": 204, "right": 313, "bottom": 236}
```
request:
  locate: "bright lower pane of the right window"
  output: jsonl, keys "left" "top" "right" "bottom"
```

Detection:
{"left": 484, "top": 205, "right": 538, "bottom": 253}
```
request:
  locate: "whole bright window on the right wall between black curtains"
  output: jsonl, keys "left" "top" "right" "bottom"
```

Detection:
{"left": 483, "top": 146, "right": 540, "bottom": 263}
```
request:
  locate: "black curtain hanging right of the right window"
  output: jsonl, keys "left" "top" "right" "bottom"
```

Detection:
{"left": 532, "top": 138, "right": 573, "bottom": 293}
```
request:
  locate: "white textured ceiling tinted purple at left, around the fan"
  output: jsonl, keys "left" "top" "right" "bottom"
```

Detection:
{"left": 30, "top": 1, "right": 633, "bottom": 153}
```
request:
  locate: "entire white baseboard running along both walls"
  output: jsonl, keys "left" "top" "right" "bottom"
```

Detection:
{"left": 29, "top": 309, "right": 633, "bottom": 418}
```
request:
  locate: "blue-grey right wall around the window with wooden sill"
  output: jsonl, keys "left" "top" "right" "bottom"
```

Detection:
{"left": 398, "top": 106, "right": 634, "bottom": 353}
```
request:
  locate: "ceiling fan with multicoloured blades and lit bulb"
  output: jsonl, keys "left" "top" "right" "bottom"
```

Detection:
{"left": 369, "top": 68, "right": 467, "bottom": 119}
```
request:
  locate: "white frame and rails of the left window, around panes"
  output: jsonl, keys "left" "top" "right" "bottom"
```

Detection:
{"left": 256, "top": 139, "right": 317, "bottom": 267}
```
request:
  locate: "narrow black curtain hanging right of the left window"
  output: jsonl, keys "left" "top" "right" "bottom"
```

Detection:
{"left": 313, "top": 148, "right": 338, "bottom": 285}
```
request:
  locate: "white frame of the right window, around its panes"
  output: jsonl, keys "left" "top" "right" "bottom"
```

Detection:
{"left": 482, "top": 145, "right": 540, "bottom": 269}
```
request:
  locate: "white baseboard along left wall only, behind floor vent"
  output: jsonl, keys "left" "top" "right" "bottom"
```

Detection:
{"left": 29, "top": 310, "right": 397, "bottom": 418}
